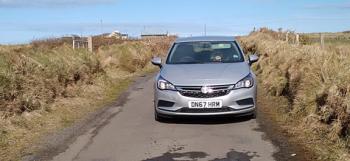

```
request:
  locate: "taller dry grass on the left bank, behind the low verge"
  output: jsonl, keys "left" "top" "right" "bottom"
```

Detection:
{"left": 0, "top": 39, "right": 172, "bottom": 118}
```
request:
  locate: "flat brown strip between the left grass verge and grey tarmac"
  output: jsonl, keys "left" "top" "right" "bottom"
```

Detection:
{"left": 21, "top": 73, "right": 154, "bottom": 161}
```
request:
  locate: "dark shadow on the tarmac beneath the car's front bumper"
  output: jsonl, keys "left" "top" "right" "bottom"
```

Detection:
{"left": 161, "top": 116, "right": 255, "bottom": 125}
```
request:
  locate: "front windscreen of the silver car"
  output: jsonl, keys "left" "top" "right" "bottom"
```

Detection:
{"left": 167, "top": 42, "right": 244, "bottom": 64}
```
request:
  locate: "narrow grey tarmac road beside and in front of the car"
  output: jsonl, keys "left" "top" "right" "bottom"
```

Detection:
{"left": 45, "top": 76, "right": 288, "bottom": 161}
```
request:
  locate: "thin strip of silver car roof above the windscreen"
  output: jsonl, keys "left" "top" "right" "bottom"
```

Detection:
{"left": 175, "top": 36, "right": 236, "bottom": 43}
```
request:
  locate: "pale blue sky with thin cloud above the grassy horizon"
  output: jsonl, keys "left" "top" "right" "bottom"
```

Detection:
{"left": 0, "top": 0, "right": 350, "bottom": 44}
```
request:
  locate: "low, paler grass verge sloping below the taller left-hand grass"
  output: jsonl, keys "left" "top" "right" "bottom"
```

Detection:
{"left": 0, "top": 76, "right": 132, "bottom": 161}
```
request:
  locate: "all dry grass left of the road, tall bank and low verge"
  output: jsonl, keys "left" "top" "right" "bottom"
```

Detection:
{"left": 0, "top": 38, "right": 173, "bottom": 160}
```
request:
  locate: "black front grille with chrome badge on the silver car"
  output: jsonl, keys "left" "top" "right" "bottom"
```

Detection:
{"left": 176, "top": 85, "right": 231, "bottom": 98}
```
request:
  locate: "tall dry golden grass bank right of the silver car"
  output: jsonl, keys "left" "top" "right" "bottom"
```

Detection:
{"left": 240, "top": 28, "right": 350, "bottom": 160}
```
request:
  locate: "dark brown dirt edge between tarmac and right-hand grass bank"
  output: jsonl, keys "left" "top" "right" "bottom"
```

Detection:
{"left": 256, "top": 83, "right": 317, "bottom": 161}
